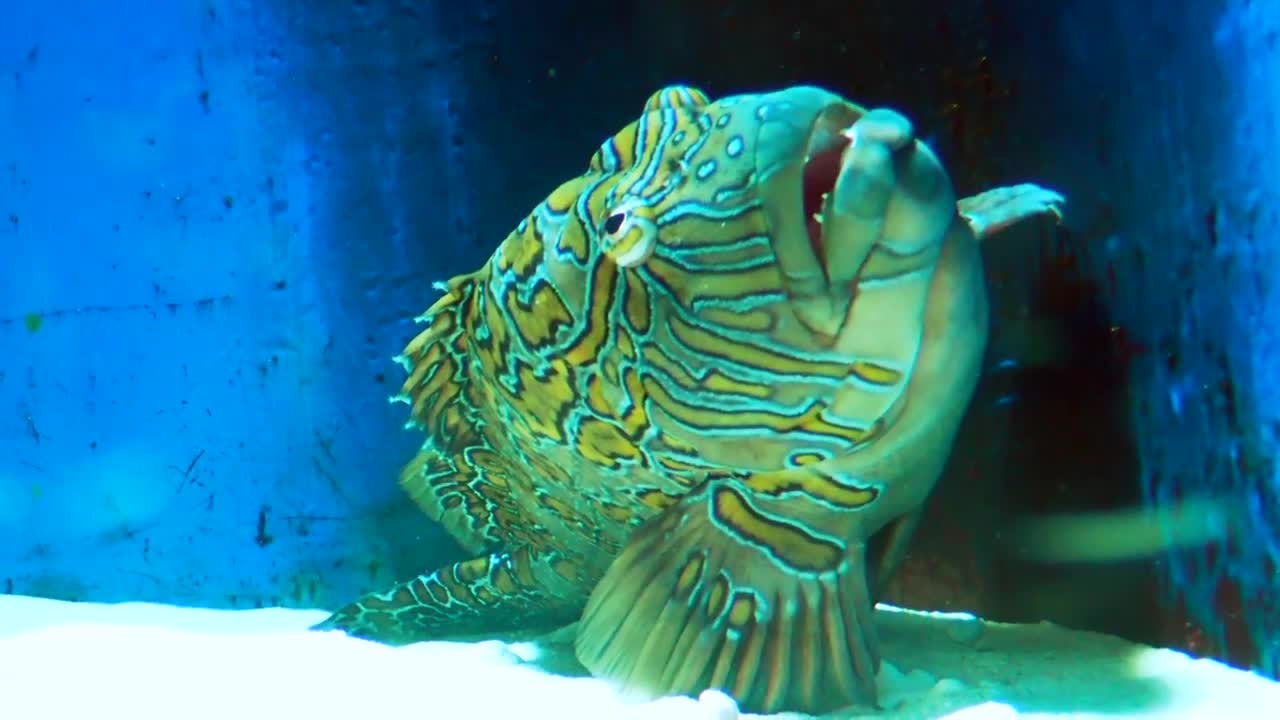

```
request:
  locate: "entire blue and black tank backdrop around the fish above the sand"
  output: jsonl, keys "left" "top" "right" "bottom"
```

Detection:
{"left": 0, "top": 0, "right": 1280, "bottom": 671}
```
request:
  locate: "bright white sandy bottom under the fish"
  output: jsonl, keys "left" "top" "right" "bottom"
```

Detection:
{"left": 0, "top": 596, "right": 1280, "bottom": 720}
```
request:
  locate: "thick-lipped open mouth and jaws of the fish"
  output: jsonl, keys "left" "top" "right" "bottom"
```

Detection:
{"left": 756, "top": 87, "right": 956, "bottom": 342}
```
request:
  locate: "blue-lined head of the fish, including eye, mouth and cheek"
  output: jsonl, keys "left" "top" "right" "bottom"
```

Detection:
{"left": 490, "top": 86, "right": 955, "bottom": 468}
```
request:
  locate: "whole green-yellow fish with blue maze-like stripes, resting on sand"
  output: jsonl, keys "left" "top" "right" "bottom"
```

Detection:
{"left": 319, "top": 87, "right": 1061, "bottom": 711}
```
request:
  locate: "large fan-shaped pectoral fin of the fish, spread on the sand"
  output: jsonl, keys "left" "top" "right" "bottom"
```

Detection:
{"left": 576, "top": 479, "right": 879, "bottom": 714}
